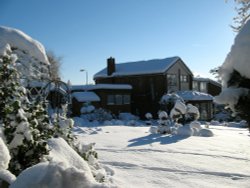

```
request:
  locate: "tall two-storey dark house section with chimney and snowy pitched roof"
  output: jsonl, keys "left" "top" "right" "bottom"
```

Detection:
{"left": 94, "top": 57, "right": 193, "bottom": 117}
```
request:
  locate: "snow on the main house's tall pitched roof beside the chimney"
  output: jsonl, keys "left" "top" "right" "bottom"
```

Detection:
{"left": 94, "top": 56, "right": 180, "bottom": 79}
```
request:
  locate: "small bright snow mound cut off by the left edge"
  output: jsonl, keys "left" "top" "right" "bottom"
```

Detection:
{"left": 0, "top": 137, "right": 10, "bottom": 169}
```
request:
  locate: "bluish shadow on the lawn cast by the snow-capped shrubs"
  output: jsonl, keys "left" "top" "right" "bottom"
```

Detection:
{"left": 128, "top": 134, "right": 188, "bottom": 147}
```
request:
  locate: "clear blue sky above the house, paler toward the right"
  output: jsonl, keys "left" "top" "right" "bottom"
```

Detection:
{"left": 0, "top": 0, "right": 235, "bottom": 84}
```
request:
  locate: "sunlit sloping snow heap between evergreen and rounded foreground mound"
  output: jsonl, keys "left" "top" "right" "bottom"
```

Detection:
{"left": 48, "top": 138, "right": 94, "bottom": 178}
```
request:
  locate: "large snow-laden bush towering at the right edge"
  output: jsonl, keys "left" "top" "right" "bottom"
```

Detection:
{"left": 215, "top": 20, "right": 250, "bottom": 128}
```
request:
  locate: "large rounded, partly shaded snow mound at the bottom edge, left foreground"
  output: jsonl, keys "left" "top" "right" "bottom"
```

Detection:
{"left": 10, "top": 162, "right": 107, "bottom": 188}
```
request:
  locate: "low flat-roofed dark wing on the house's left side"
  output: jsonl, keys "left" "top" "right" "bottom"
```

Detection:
{"left": 71, "top": 84, "right": 132, "bottom": 116}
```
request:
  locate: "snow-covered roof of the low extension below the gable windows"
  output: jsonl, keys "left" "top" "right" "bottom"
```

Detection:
{"left": 176, "top": 91, "right": 213, "bottom": 101}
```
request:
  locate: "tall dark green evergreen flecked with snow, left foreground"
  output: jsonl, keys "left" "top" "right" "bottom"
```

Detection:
{"left": 0, "top": 52, "right": 49, "bottom": 175}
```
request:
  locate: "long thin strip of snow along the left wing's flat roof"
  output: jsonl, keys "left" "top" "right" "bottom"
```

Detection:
{"left": 71, "top": 84, "right": 132, "bottom": 90}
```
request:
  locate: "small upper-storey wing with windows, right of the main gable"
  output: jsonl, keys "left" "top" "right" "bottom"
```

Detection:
{"left": 193, "top": 77, "right": 222, "bottom": 96}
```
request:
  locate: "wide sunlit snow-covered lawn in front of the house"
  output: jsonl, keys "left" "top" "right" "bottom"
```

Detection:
{"left": 74, "top": 125, "right": 250, "bottom": 188}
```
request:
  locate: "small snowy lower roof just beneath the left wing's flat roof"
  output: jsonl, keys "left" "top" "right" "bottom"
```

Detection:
{"left": 72, "top": 91, "right": 100, "bottom": 102}
